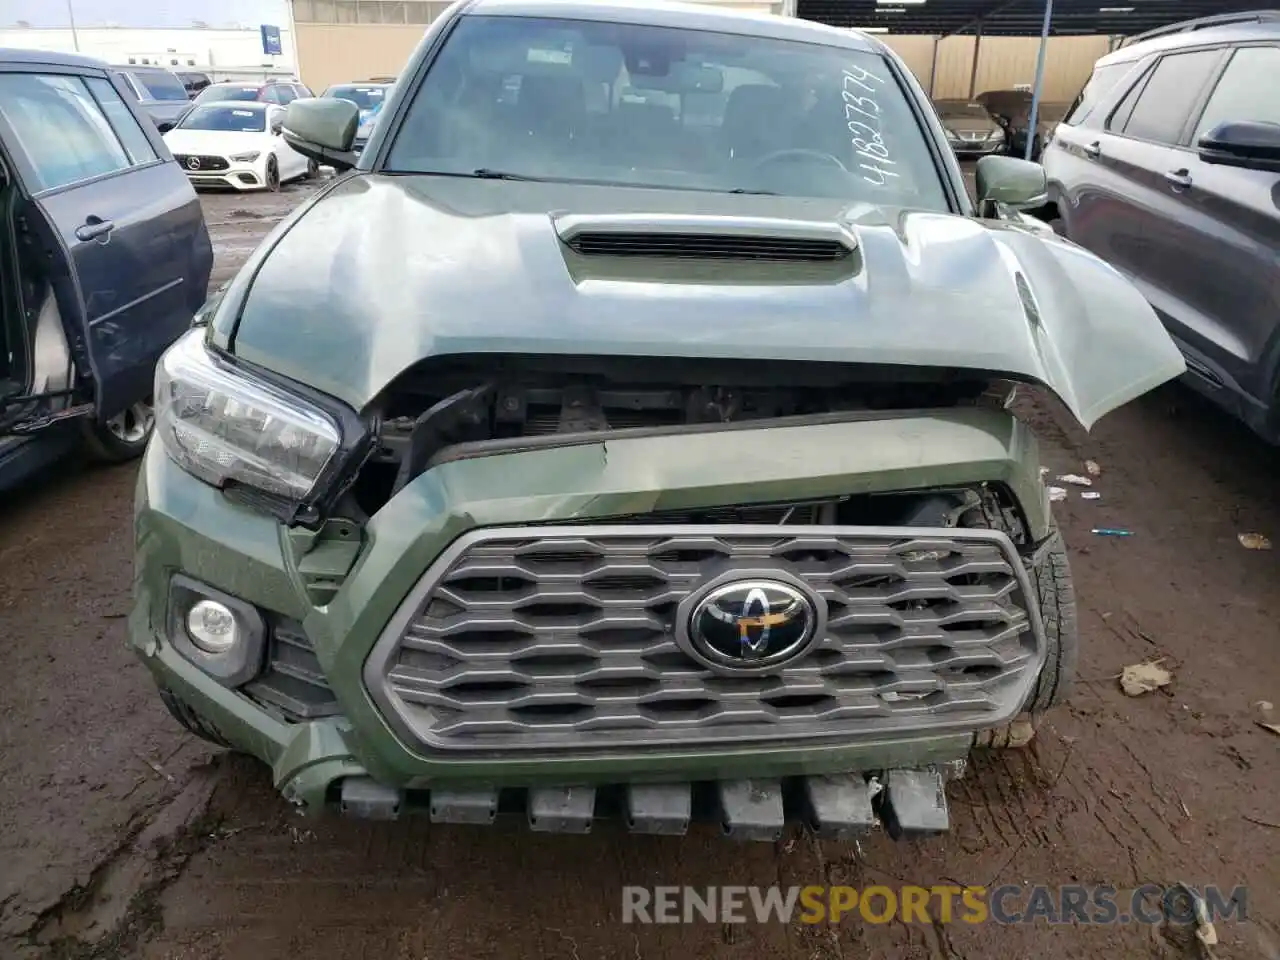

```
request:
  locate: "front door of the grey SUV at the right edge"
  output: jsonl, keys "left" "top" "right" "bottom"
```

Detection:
{"left": 1152, "top": 44, "right": 1280, "bottom": 403}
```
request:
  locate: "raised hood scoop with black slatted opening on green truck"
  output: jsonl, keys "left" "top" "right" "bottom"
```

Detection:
{"left": 553, "top": 214, "right": 856, "bottom": 264}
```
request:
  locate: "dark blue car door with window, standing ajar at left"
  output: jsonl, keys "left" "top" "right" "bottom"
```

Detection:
{"left": 0, "top": 64, "right": 212, "bottom": 419}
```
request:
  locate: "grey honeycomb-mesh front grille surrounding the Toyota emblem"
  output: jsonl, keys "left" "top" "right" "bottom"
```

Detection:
{"left": 365, "top": 524, "right": 1043, "bottom": 754}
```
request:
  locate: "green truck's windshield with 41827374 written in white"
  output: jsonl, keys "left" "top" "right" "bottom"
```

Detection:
{"left": 387, "top": 17, "right": 947, "bottom": 210}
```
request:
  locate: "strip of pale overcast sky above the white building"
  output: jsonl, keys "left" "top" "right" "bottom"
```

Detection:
{"left": 0, "top": 0, "right": 288, "bottom": 28}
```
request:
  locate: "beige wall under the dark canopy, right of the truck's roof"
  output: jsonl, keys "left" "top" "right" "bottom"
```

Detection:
{"left": 879, "top": 35, "right": 1110, "bottom": 102}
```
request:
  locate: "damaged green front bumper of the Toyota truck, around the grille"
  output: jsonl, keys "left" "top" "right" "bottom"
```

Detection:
{"left": 129, "top": 410, "right": 1048, "bottom": 822}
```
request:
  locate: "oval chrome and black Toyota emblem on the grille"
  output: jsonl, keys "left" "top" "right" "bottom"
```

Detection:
{"left": 677, "top": 575, "right": 826, "bottom": 673}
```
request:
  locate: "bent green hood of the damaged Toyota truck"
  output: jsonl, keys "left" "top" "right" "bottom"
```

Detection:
{"left": 211, "top": 174, "right": 1185, "bottom": 426}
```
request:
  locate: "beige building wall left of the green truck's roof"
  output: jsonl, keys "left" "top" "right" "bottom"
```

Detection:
{"left": 297, "top": 23, "right": 426, "bottom": 93}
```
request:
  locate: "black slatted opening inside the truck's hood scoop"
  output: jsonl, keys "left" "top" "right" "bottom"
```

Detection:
{"left": 568, "top": 230, "right": 850, "bottom": 262}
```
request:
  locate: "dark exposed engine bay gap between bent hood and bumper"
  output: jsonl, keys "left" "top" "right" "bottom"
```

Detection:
{"left": 343, "top": 356, "right": 1014, "bottom": 522}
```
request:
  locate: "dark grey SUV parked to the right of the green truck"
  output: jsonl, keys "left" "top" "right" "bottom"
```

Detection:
{"left": 1041, "top": 12, "right": 1280, "bottom": 443}
